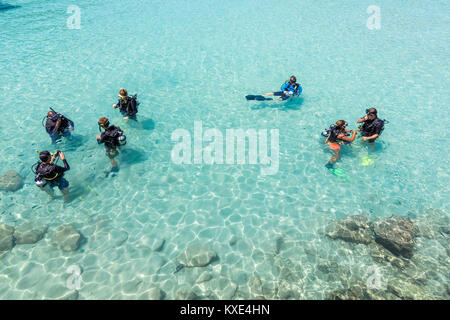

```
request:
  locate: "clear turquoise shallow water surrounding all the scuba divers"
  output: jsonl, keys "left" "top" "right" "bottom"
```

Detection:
{"left": 0, "top": 0, "right": 450, "bottom": 299}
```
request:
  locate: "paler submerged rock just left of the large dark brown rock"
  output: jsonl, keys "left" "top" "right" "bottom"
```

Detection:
{"left": 327, "top": 214, "right": 373, "bottom": 244}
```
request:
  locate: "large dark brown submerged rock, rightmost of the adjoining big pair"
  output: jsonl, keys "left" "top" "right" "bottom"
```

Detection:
{"left": 373, "top": 216, "right": 416, "bottom": 258}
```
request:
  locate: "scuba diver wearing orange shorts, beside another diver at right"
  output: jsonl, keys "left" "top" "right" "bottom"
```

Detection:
{"left": 322, "top": 120, "right": 356, "bottom": 168}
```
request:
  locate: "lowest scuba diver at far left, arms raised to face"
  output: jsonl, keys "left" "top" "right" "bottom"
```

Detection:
{"left": 32, "top": 150, "right": 71, "bottom": 202}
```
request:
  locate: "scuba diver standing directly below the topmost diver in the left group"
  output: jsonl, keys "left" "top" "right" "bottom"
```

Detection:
{"left": 97, "top": 117, "right": 127, "bottom": 171}
